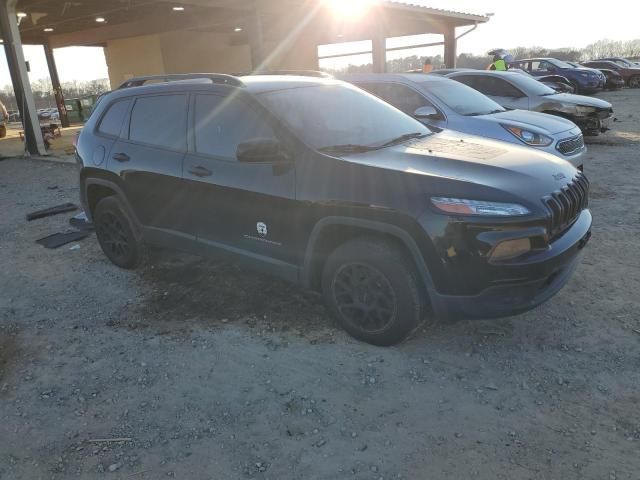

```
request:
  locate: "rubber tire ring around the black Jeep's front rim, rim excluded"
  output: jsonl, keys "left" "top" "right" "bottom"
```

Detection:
{"left": 322, "top": 239, "right": 424, "bottom": 346}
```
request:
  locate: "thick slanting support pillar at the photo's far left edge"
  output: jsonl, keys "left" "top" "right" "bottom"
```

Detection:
{"left": 0, "top": 0, "right": 46, "bottom": 155}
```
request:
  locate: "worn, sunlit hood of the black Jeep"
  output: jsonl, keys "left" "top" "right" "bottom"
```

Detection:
{"left": 342, "top": 130, "right": 577, "bottom": 203}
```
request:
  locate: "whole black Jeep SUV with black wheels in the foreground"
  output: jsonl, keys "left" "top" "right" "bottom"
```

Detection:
{"left": 77, "top": 75, "right": 591, "bottom": 345}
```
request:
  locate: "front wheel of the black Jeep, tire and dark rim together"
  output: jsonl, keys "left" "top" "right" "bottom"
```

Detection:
{"left": 322, "top": 237, "right": 426, "bottom": 346}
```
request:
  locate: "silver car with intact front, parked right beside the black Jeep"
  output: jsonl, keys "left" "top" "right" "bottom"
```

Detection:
{"left": 342, "top": 73, "right": 586, "bottom": 169}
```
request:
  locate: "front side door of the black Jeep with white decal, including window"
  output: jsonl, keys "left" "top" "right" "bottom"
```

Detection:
{"left": 184, "top": 92, "right": 296, "bottom": 262}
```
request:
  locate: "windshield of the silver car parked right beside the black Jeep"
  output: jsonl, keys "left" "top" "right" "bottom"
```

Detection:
{"left": 422, "top": 81, "right": 505, "bottom": 116}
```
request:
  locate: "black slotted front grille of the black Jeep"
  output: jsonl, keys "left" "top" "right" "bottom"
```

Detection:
{"left": 542, "top": 172, "right": 589, "bottom": 238}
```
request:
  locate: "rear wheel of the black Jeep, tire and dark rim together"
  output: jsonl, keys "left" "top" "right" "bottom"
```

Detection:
{"left": 93, "top": 196, "right": 146, "bottom": 270}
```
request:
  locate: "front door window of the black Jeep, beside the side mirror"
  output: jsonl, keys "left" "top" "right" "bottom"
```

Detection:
{"left": 195, "top": 95, "right": 276, "bottom": 160}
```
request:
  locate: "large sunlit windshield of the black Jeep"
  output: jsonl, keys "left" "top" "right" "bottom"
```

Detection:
{"left": 258, "top": 84, "right": 431, "bottom": 150}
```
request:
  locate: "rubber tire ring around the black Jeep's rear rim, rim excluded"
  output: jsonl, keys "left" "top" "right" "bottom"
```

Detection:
{"left": 93, "top": 196, "right": 144, "bottom": 269}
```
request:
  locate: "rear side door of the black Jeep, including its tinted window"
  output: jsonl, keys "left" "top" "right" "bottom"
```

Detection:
{"left": 108, "top": 93, "right": 190, "bottom": 234}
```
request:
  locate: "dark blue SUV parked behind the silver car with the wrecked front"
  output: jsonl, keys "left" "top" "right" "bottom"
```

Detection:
{"left": 509, "top": 58, "right": 607, "bottom": 93}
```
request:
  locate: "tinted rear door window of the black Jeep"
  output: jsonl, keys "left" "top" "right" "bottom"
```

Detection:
{"left": 129, "top": 95, "right": 187, "bottom": 150}
